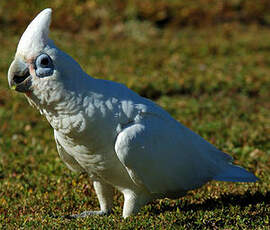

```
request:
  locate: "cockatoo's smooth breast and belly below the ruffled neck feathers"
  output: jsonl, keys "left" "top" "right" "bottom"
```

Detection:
{"left": 55, "top": 131, "right": 134, "bottom": 189}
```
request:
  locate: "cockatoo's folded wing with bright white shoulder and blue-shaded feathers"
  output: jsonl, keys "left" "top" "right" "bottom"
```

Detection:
{"left": 115, "top": 113, "right": 232, "bottom": 194}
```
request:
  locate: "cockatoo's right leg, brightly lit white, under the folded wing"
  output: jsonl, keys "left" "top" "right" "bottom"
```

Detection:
{"left": 123, "top": 191, "right": 151, "bottom": 218}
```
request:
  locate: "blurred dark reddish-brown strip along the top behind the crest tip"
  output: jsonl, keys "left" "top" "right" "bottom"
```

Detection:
{"left": 0, "top": 0, "right": 270, "bottom": 32}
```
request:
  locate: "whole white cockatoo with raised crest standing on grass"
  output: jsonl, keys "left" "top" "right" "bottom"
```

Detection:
{"left": 8, "top": 9, "right": 257, "bottom": 218}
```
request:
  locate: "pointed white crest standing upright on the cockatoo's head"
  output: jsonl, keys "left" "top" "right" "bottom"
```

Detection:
{"left": 17, "top": 8, "right": 52, "bottom": 58}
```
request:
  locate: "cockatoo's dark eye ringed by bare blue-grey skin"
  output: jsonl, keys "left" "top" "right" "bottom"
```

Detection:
{"left": 35, "top": 54, "right": 54, "bottom": 77}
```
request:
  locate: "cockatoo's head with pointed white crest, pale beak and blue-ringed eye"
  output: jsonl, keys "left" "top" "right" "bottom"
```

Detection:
{"left": 8, "top": 9, "right": 82, "bottom": 106}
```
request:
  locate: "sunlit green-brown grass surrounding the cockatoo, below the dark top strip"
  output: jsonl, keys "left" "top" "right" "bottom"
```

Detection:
{"left": 0, "top": 10, "right": 270, "bottom": 229}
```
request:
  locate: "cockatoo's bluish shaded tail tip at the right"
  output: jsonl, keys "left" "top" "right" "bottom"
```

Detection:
{"left": 213, "top": 163, "right": 258, "bottom": 182}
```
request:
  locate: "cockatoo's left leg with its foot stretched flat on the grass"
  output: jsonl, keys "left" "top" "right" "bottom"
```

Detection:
{"left": 66, "top": 181, "right": 113, "bottom": 218}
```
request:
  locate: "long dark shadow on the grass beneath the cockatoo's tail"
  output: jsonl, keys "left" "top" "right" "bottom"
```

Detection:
{"left": 152, "top": 191, "right": 270, "bottom": 214}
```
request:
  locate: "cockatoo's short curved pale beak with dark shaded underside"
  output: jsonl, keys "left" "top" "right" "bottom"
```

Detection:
{"left": 8, "top": 59, "right": 32, "bottom": 93}
